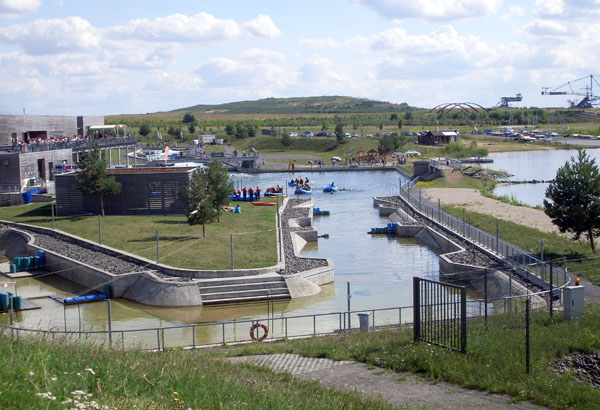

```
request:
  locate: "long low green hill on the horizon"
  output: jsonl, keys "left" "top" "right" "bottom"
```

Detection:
{"left": 170, "top": 96, "right": 409, "bottom": 114}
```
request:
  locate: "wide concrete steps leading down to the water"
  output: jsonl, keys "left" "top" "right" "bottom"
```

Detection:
{"left": 198, "top": 274, "right": 291, "bottom": 305}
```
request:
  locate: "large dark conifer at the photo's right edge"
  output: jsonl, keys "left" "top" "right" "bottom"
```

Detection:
{"left": 544, "top": 149, "right": 600, "bottom": 253}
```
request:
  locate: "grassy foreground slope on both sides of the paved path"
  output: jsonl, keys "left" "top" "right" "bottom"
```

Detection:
{"left": 0, "top": 306, "right": 600, "bottom": 410}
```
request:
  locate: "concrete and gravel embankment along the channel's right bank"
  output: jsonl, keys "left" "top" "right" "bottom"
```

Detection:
{"left": 373, "top": 198, "right": 544, "bottom": 303}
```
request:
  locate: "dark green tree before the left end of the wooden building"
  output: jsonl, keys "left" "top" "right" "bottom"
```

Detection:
{"left": 75, "top": 144, "right": 121, "bottom": 216}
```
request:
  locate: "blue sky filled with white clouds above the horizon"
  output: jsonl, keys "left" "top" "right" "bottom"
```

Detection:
{"left": 0, "top": 0, "right": 600, "bottom": 115}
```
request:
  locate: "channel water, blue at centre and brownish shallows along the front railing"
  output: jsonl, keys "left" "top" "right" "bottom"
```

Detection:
{"left": 0, "top": 171, "right": 474, "bottom": 346}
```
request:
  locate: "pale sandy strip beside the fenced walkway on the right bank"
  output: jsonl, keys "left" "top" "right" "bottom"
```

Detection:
{"left": 422, "top": 188, "right": 563, "bottom": 235}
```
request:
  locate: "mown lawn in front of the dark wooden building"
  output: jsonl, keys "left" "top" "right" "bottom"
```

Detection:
{"left": 0, "top": 198, "right": 277, "bottom": 269}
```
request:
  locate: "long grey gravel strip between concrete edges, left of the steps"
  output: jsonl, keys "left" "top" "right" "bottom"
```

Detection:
{"left": 0, "top": 224, "right": 166, "bottom": 277}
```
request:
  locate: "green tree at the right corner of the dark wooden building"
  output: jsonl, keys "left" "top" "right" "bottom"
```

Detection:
{"left": 179, "top": 168, "right": 217, "bottom": 237}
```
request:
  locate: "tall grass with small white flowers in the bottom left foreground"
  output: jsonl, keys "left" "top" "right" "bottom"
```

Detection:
{"left": 0, "top": 335, "right": 392, "bottom": 409}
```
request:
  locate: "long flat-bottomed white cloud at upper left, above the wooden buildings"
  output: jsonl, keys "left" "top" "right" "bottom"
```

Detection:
{"left": 108, "top": 12, "right": 280, "bottom": 42}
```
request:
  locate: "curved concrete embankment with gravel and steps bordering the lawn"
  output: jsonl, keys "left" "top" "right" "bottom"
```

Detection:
{"left": 0, "top": 199, "right": 334, "bottom": 307}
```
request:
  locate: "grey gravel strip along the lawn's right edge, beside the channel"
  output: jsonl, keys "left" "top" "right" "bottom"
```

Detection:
{"left": 281, "top": 199, "right": 327, "bottom": 275}
